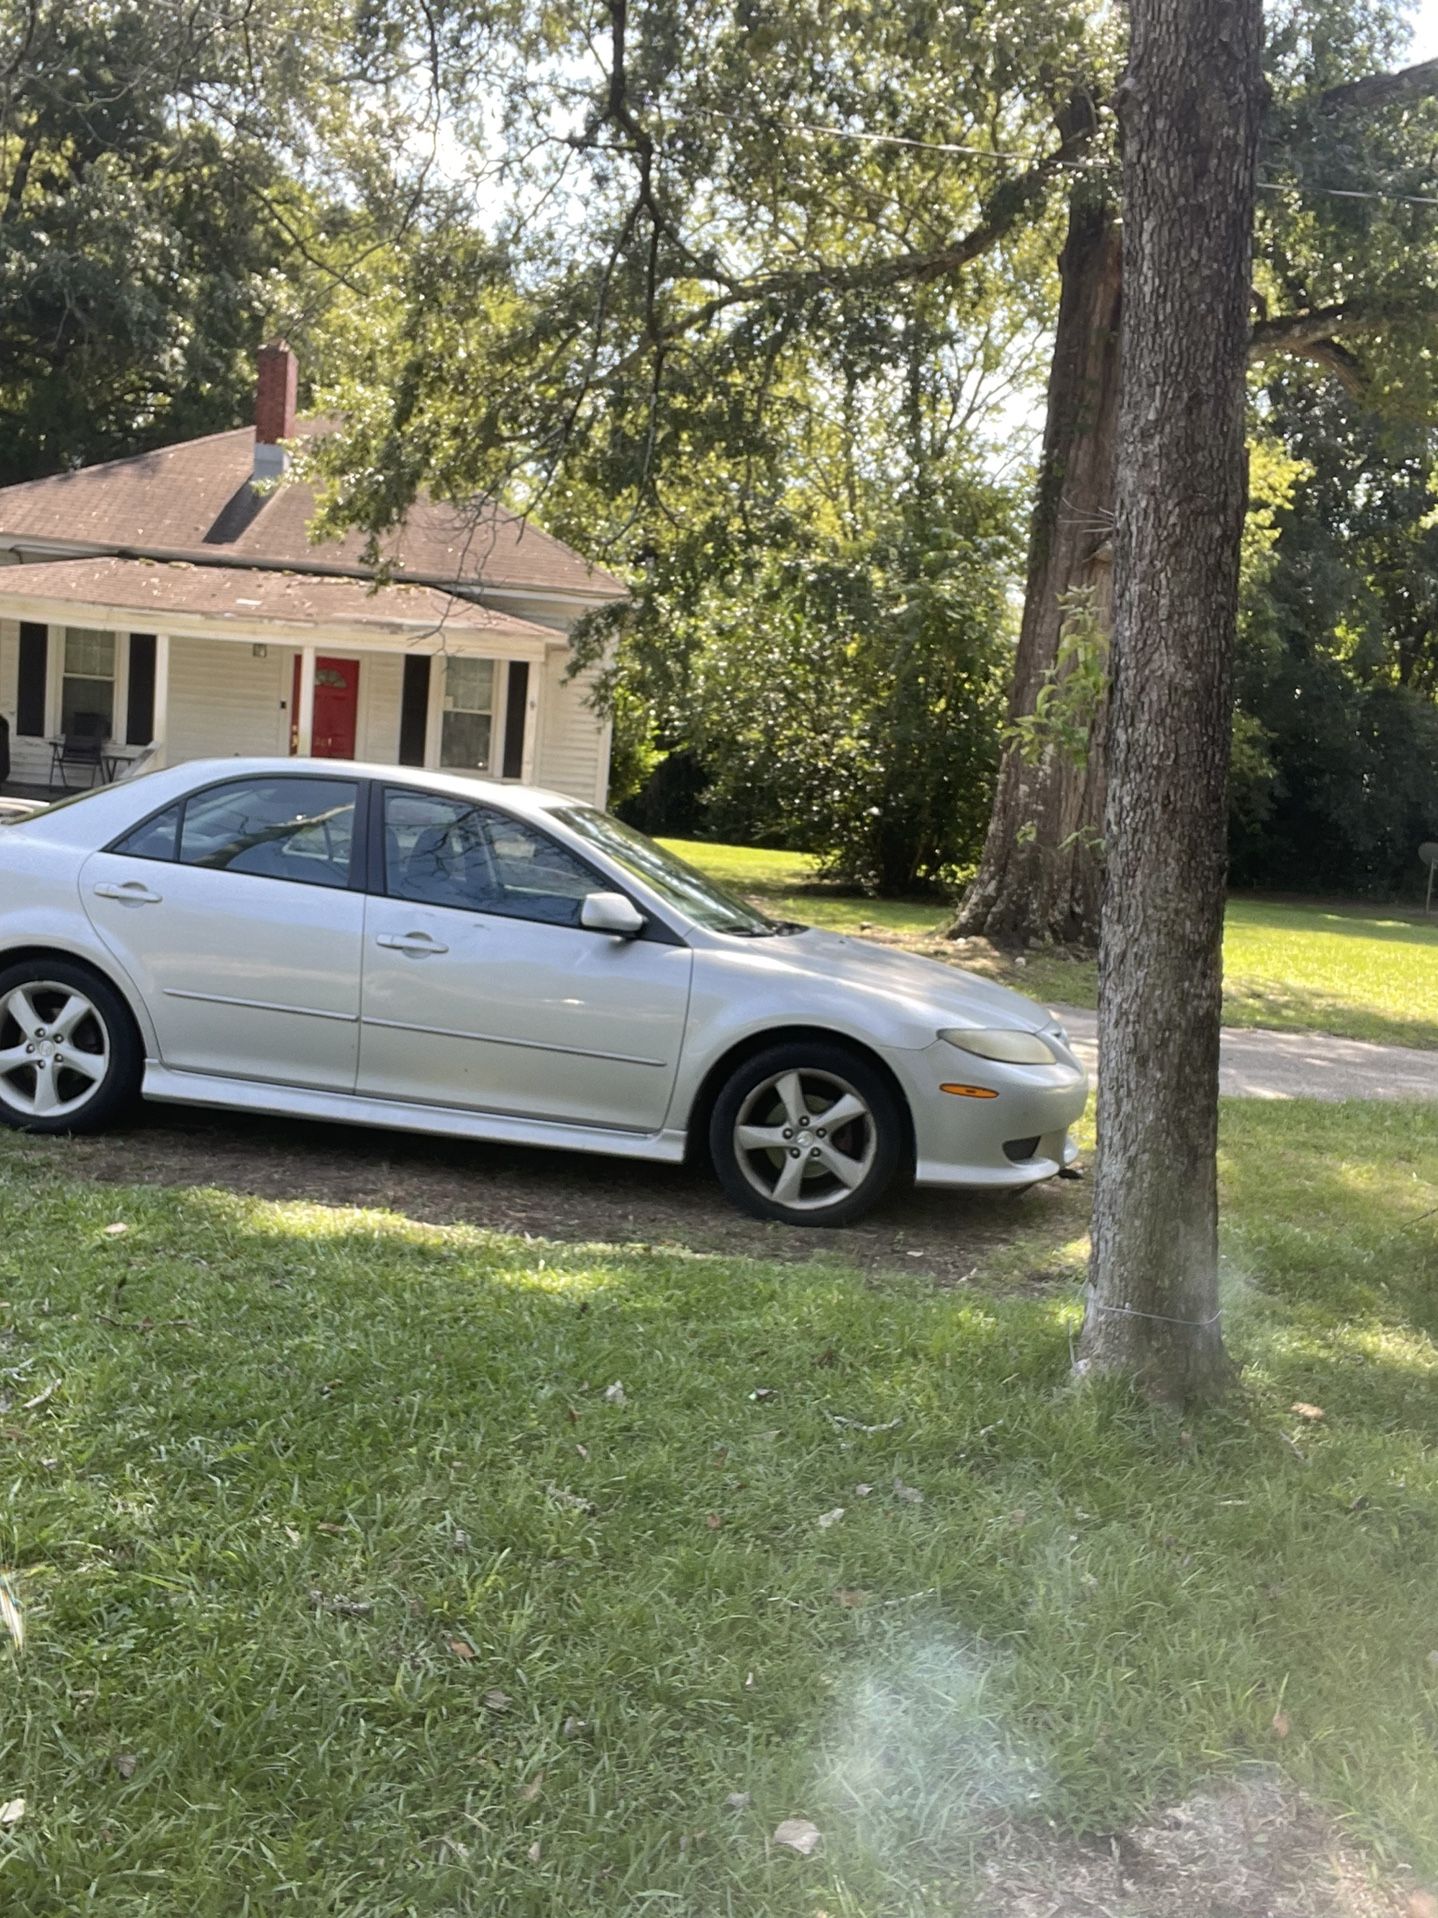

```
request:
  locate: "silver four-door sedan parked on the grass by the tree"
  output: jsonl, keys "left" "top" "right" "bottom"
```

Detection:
{"left": 0, "top": 760, "right": 1087, "bottom": 1226}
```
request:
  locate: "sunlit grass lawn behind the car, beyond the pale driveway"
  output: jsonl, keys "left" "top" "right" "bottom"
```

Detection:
{"left": 665, "top": 840, "right": 1438, "bottom": 1047}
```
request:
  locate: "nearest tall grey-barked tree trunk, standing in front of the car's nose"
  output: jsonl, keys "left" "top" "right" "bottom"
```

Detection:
{"left": 1079, "top": 0, "right": 1264, "bottom": 1400}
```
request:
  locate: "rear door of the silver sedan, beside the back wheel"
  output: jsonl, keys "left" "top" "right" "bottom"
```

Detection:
{"left": 81, "top": 773, "right": 364, "bottom": 1091}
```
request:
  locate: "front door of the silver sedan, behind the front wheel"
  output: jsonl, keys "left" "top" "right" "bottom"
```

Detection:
{"left": 359, "top": 786, "right": 692, "bottom": 1132}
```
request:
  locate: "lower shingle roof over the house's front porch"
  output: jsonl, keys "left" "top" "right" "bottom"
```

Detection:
{"left": 0, "top": 558, "right": 562, "bottom": 650}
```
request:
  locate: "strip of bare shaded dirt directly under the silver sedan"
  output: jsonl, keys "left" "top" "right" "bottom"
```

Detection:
{"left": 27, "top": 1107, "right": 1087, "bottom": 1285}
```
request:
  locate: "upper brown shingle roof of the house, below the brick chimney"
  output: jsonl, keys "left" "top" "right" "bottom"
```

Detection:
{"left": 0, "top": 420, "right": 627, "bottom": 598}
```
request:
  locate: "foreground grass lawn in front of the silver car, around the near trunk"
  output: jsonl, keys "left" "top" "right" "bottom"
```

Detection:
{"left": 0, "top": 1103, "right": 1438, "bottom": 1918}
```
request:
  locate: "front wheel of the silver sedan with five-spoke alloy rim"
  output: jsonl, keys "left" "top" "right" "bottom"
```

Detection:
{"left": 709, "top": 1040, "right": 905, "bottom": 1226}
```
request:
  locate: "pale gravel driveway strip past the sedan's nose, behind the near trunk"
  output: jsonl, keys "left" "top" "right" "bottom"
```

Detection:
{"left": 1055, "top": 1005, "right": 1438, "bottom": 1099}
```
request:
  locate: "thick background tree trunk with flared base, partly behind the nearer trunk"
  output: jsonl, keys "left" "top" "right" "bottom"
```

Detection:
{"left": 953, "top": 182, "right": 1120, "bottom": 944}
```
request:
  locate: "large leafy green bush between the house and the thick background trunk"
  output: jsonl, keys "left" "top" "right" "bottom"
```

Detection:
{"left": 694, "top": 480, "right": 1010, "bottom": 894}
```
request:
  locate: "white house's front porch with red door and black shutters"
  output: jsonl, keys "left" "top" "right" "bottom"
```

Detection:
{"left": 0, "top": 558, "right": 604, "bottom": 804}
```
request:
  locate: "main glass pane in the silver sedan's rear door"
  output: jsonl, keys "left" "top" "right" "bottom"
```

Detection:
{"left": 180, "top": 779, "right": 357, "bottom": 886}
